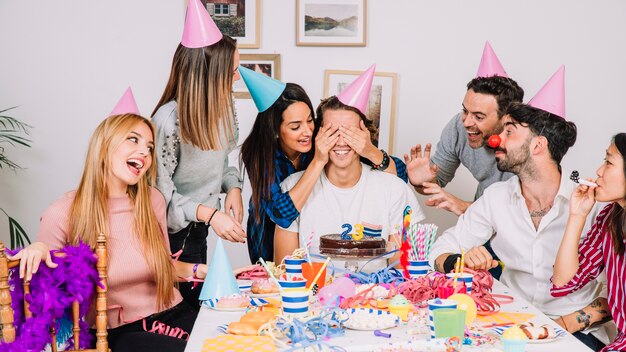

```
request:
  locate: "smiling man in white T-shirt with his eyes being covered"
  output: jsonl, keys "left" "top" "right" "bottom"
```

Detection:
{"left": 274, "top": 96, "right": 424, "bottom": 271}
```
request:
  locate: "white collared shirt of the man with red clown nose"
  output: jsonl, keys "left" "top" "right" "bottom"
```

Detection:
{"left": 429, "top": 173, "right": 606, "bottom": 318}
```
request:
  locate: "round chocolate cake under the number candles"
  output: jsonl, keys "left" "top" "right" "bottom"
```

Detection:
{"left": 320, "top": 234, "right": 387, "bottom": 258}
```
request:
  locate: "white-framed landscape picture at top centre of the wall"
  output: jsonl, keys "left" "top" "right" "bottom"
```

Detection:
{"left": 296, "top": 0, "right": 367, "bottom": 46}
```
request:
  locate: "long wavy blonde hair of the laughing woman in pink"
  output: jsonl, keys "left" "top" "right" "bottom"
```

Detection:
{"left": 69, "top": 114, "right": 174, "bottom": 309}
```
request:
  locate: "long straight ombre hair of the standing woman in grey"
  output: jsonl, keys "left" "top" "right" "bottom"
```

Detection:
{"left": 152, "top": 35, "right": 237, "bottom": 150}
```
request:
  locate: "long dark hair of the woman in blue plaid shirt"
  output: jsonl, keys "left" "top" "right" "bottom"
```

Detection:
{"left": 241, "top": 83, "right": 315, "bottom": 223}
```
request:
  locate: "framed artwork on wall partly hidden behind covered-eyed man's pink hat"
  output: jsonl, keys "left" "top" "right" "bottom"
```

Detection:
{"left": 324, "top": 70, "right": 398, "bottom": 154}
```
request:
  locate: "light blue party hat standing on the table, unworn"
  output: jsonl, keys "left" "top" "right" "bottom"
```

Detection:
{"left": 200, "top": 238, "right": 241, "bottom": 301}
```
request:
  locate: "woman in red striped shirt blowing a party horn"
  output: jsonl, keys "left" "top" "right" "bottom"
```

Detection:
{"left": 551, "top": 133, "right": 626, "bottom": 352}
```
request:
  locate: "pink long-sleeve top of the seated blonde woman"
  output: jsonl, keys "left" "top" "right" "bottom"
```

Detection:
{"left": 37, "top": 188, "right": 182, "bottom": 328}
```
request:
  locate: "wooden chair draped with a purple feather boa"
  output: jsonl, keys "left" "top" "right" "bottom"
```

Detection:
{"left": 0, "top": 234, "right": 109, "bottom": 352}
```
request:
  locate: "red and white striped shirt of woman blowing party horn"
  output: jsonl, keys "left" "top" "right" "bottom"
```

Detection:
{"left": 551, "top": 203, "right": 626, "bottom": 352}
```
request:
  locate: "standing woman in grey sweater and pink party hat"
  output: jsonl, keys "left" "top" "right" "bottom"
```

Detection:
{"left": 152, "top": 0, "right": 246, "bottom": 308}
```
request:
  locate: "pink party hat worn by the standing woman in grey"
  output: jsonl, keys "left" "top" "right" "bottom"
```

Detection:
{"left": 180, "top": 0, "right": 222, "bottom": 48}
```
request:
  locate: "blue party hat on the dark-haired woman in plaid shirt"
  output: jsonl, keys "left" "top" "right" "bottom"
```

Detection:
{"left": 239, "top": 66, "right": 287, "bottom": 112}
